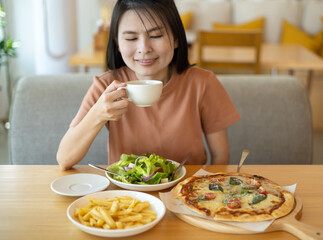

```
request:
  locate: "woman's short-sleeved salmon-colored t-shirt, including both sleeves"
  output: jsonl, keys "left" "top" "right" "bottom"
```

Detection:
{"left": 70, "top": 67, "right": 240, "bottom": 164}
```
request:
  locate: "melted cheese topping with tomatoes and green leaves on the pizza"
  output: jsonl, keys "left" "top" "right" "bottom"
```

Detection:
{"left": 184, "top": 176, "right": 285, "bottom": 216}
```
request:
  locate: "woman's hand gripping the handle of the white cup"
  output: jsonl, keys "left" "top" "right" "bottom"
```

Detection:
{"left": 93, "top": 80, "right": 129, "bottom": 122}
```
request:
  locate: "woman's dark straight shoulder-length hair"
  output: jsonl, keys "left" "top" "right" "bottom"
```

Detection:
{"left": 106, "top": 0, "right": 190, "bottom": 73}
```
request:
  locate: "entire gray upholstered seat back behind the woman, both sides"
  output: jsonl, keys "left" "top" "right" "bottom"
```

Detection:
{"left": 9, "top": 74, "right": 312, "bottom": 164}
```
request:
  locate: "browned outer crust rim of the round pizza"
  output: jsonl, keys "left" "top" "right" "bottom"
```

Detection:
{"left": 174, "top": 173, "right": 295, "bottom": 222}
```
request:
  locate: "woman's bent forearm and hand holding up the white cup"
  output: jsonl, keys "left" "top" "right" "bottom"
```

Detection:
{"left": 57, "top": 80, "right": 129, "bottom": 170}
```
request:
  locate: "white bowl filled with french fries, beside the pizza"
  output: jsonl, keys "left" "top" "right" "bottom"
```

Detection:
{"left": 67, "top": 190, "right": 166, "bottom": 237}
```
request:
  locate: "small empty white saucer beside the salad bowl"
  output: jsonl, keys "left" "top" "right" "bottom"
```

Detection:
{"left": 50, "top": 173, "right": 110, "bottom": 196}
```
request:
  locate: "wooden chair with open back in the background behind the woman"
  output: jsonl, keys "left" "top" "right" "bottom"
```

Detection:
{"left": 198, "top": 30, "right": 262, "bottom": 74}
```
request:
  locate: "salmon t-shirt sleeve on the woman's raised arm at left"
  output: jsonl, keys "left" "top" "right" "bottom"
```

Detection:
{"left": 70, "top": 76, "right": 108, "bottom": 127}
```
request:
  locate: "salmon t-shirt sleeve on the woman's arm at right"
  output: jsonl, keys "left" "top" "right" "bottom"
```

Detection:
{"left": 201, "top": 73, "right": 240, "bottom": 134}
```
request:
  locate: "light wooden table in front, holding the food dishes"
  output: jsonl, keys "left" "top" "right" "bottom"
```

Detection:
{"left": 0, "top": 165, "right": 323, "bottom": 240}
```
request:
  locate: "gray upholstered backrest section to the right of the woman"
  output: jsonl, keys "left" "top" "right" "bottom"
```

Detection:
{"left": 218, "top": 75, "right": 313, "bottom": 164}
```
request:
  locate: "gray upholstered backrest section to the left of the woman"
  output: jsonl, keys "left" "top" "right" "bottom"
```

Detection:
{"left": 9, "top": 74, "right": 107, "bottom": 164}
